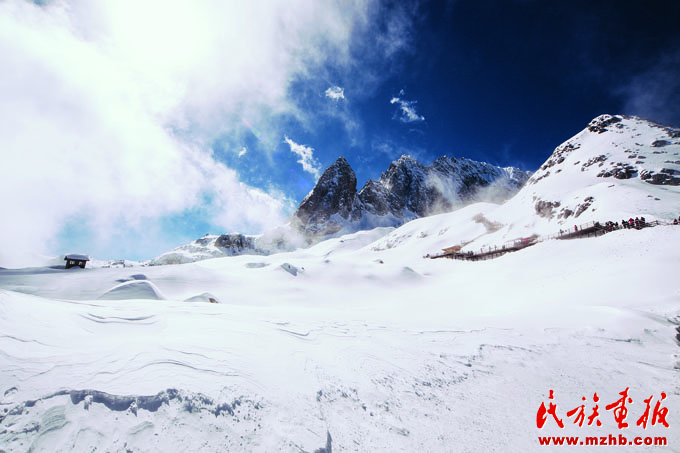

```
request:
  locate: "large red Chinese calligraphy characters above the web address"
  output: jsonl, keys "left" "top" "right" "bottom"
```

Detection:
{"left": 536, "top": 387, "right": 668, "bottom": 429}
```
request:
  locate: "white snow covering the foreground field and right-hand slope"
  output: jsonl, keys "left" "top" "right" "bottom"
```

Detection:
{"left": 0, "top": 115, "right": 680, "bottom": 452}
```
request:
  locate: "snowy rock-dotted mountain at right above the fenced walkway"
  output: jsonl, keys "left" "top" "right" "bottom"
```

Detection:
{"left": 373, "top": 115, "right": 680, "bottom": 259}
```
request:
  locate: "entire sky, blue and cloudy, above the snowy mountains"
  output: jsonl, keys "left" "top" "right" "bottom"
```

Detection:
{"left": 0, "top": 0, "right": 680, "bottom": 266}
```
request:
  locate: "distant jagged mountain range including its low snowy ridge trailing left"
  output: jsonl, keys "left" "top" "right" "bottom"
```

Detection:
{"left": 149, "top": 156, "right": 530, "bottom": 265}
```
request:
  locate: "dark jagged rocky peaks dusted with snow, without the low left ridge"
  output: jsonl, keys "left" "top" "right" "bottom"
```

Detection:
{"left": 295, "top": 156, "right": 530, "bottom": 236}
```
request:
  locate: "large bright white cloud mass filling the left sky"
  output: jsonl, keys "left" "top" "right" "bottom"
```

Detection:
{"left": 0, "top": 0, "right": 378, "bottom": 266}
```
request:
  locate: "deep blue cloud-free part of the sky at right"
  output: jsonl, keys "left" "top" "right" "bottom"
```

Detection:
{"left": 214, "top": 1, "right": 680, "bottom": 207}
